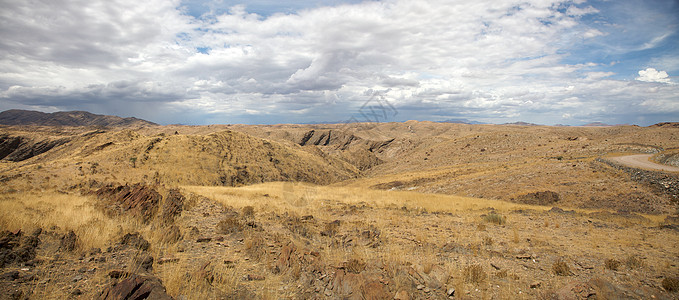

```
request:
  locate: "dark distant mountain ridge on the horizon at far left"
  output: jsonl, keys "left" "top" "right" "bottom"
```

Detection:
{"left": 0, "top": 109, "right": 157, "bottom": 127}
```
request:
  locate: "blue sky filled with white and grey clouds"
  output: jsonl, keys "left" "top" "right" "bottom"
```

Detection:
{"left": 0, "top": 0, "right": 679, "bottom": 126}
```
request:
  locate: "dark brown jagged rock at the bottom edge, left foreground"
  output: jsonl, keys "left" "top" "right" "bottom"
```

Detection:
{"left": 98, "top": 275, "right": 172, "bottom": 300}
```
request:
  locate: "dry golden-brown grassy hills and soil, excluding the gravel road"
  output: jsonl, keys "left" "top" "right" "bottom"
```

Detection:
{"left": 0, "top": 121, "right": 679, "bottom": 299}
